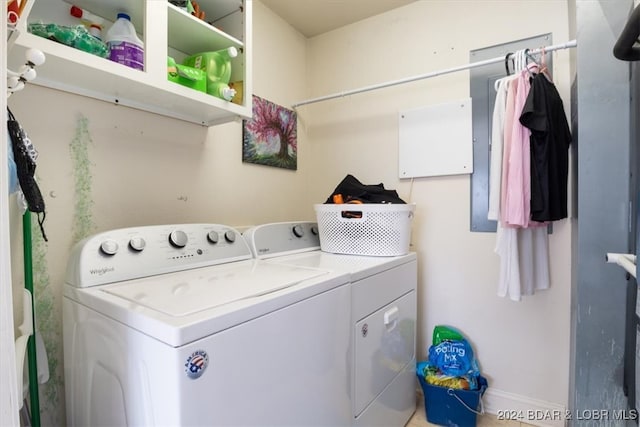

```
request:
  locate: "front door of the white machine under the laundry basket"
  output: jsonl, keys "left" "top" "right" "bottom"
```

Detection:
{"left": 354, "top": 291, "right": 416, "bottom": 417}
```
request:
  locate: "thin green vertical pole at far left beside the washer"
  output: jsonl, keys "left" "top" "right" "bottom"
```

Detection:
{"left": 23, "top": 210, "right": 40, "bottom": 427}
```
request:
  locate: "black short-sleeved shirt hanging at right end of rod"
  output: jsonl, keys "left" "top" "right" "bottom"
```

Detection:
{"left": 520, "top": 73, "right": 571, "bottom": 222}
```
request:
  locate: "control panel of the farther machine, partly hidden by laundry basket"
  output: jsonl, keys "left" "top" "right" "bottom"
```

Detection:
{"left": 244, "top": 221, "right": 320, "bottom": 258}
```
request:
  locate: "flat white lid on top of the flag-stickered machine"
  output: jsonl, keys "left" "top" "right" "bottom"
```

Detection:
{"left": 103, "top": 263, "right": 328, "bottom": 317}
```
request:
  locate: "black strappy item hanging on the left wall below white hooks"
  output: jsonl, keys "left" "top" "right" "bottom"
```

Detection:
{"left": 7, "top": 108, "right": 48, "bottom": 242}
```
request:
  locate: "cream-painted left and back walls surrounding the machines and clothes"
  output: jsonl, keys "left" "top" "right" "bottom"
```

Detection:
{"left": 9, "top": 0, "right": 571, "bottom": 425}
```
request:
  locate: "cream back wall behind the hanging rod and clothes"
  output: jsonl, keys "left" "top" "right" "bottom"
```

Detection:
{"left": 299, "top": 0, "right": 571, "bottom": 409}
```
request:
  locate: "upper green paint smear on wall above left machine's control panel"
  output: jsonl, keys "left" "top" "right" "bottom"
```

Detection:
{"left": 69, "top": 115, "right": 96, "bottom": 243}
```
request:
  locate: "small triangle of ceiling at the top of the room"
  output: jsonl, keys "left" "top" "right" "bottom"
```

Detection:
{"left": 261, "top": 0, "right": 415, "bottom": 37}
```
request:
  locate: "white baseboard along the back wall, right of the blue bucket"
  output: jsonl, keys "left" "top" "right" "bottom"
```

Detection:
{"left": 482, "top": 387, "right": 570, "bottom": 427}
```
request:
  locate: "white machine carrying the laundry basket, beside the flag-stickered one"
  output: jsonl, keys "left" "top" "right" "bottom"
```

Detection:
{"left": 244, "top": 222, "right": 417, "bottom": 427}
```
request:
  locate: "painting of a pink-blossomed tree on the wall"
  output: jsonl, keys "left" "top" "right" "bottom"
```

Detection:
{"left": 242, "top": 95, "right": 298, "bottom": 170}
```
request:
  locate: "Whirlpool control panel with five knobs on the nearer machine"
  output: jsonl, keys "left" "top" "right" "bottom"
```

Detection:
{"left": 66, "top": 224, "right": 252, "bottom": 287}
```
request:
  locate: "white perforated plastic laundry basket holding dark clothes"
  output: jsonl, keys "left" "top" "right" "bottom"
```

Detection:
{"left": 314, "top": 203, "right": 415, "bottom": 256}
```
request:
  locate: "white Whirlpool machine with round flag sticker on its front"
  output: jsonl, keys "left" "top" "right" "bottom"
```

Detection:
{"left": 63, "top": 224, "right": 351, "bottom": 426}
